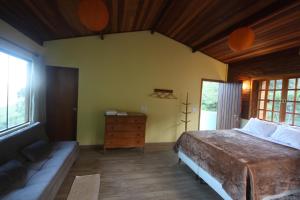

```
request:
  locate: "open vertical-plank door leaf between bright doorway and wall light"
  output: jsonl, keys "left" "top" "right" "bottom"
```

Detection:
{"left": 217, "top": 83, "right": 242, "bottom": 129}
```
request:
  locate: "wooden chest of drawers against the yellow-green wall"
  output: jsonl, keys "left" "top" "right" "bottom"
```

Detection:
{"left": 104, "top": 113, "right": 147, "bottom": 149}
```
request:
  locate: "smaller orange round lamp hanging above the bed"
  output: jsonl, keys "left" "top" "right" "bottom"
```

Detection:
{"left": 228, "top": 27, "right": 255, "bottom": 51}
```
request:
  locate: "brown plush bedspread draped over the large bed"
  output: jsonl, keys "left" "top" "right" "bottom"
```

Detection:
{"left": 174, "top": 130, "right": 300, "bottom": 200}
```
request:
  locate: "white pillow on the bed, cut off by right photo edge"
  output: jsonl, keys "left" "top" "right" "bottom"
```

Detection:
{"left": 271, "top": 125, "right": 300, "bottom": 149}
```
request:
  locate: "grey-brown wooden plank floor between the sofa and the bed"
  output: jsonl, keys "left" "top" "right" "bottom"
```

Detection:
{"left": 56, "top": 144, "right": 221, "bottom": 200}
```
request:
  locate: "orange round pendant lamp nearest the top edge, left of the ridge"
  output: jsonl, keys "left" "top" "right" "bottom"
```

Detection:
{"left": 78, "top": 0, "right": 109, "bottom": 32}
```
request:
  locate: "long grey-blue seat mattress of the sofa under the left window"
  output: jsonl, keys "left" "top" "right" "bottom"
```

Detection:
{"left": 0, "top": 142, "right": 78, "bottom": 200}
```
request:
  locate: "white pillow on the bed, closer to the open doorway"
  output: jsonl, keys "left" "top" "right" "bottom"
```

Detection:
{"left": 243, "top": 118, "right": 277, "bottom": 137}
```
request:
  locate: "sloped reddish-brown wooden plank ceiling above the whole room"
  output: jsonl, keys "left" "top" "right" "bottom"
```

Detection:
{"left": 0, "top": 0, "right": 300, "bottom": 63}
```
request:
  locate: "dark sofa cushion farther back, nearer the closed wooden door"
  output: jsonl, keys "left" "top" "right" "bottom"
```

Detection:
{"left": 21, "top": 140, "right": 51, "bottom": 162}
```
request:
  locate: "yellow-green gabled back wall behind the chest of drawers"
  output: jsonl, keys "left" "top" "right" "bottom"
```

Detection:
{"left": 45, "top": 32, "right": 227, "bottom": 145}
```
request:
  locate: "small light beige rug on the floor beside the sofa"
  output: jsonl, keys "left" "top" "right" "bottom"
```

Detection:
{"left": 67, "top": 174, "right": 100, "bottom": 200}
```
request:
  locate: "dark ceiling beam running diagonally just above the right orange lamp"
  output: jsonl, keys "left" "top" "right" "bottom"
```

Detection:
{"left": 192, "top": 0, "right": 295, "bottom": 53}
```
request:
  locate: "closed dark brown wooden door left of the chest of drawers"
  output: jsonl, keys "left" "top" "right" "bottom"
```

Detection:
{"left": 46, "top": 66, "right": 78, "bottom": 141}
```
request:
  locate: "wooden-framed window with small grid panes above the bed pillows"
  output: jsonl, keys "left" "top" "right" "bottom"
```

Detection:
{"left": 257, "top": 78, "right": 300, "bottom": 126}
